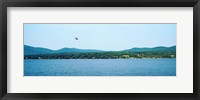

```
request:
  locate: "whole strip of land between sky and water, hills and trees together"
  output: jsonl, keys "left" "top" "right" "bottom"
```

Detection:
{"left": 24, "top": 45, "right": 176, "bottom": 59}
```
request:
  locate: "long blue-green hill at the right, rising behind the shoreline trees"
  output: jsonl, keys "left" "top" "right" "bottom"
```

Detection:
{"left": 123, "top": 46, "right": 176, "bottom": 52}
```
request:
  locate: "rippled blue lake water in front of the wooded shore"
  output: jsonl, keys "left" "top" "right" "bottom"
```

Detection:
{"left": 24, "top": 58, "right": 176, "bottom": 76}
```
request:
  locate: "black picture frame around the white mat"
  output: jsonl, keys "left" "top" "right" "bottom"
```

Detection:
{"left": 0, "top": 0, "right": 200, "bottom": 100}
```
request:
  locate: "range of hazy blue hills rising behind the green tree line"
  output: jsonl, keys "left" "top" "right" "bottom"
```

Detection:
{"left": 24, "top": 45, "right": 176, "bottom": 55}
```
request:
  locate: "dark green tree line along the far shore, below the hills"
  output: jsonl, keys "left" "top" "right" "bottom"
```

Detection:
{"left": 24, "top": 51, "right": 176, "bottom": 59}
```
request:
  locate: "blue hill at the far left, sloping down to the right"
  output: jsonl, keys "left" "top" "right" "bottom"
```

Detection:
{"left": 24, "top": 45, "right": 53, "bottom": 55}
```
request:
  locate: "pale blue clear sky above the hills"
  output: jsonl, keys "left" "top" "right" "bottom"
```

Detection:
{"left": 24, "top": 24, "right": 176, "bottom": 51}
